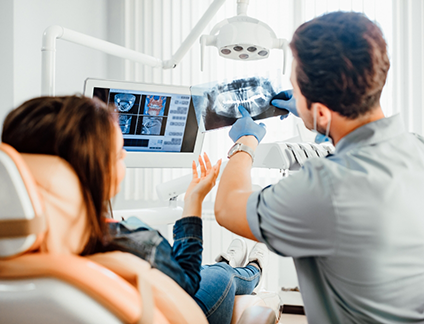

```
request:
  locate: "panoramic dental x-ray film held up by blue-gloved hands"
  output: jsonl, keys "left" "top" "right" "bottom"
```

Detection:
{"left": 191, "top": 77, "right": 288, "bottom": 131}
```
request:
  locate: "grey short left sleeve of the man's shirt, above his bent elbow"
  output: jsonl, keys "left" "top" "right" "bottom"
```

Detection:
{"left": 246, "top": 159, "right": 337, "bottom": 258}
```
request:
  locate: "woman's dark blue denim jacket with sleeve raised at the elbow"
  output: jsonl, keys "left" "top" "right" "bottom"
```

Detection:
{"left": 101, "top": 217, "right": 203, "bottom": 296}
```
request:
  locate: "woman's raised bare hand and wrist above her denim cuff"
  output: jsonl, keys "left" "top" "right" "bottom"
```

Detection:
{"left": 183, "top": 153, "right": 221, "bottom": 217}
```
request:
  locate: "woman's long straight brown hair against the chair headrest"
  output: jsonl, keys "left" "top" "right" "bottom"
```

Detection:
{"left": 2, "top": 96, "right": 116, "bottom": 254}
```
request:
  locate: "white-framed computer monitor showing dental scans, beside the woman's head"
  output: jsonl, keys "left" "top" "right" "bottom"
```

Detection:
{"left": 84, "top": 79, "right": 204, "bottom": 168}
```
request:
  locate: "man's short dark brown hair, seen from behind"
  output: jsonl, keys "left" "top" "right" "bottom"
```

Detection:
{"left": 290, "top": 12, "right": 390, "bottom": 119}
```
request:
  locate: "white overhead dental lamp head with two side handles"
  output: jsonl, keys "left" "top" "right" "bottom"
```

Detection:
{"left": 200, "top": 0, "right": 288, "bottom": 73}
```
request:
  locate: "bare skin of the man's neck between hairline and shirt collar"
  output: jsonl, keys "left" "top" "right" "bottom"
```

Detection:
{"left": 330, "top": 106, "right": 384, "bottom": 145}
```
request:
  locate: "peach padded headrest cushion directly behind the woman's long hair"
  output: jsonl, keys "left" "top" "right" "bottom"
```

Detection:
{"left": 21, "top": 154, "right": 90, "bottom": 254}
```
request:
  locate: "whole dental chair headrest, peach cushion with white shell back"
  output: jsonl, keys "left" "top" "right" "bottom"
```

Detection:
{"left": 0, "top": 143, "right": 89, "bottom": 258}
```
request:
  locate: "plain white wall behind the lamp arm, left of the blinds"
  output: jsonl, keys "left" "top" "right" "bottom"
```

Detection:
{"left": 0, "top": 0, "right": 109, "bottom": 133}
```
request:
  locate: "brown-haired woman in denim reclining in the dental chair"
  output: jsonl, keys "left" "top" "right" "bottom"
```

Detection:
{"left": 2, "top": 96, "right": 268, "bottom": 324}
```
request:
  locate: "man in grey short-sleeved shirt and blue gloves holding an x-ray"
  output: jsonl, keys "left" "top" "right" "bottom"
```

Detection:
{"left": 215, "top": 12, "right": 424, "bottom": 324}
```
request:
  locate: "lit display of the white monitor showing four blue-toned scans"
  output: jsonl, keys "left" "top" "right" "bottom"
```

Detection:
{"left": 94, "top": 88, "right": 190, "bottom": 152}
